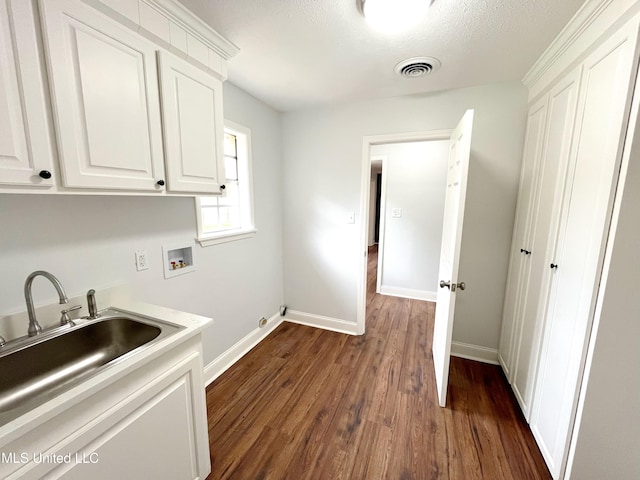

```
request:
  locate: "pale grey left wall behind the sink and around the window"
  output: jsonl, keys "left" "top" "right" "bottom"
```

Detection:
{"left": 0, "top": 84, "right": 283, "bottom": 363}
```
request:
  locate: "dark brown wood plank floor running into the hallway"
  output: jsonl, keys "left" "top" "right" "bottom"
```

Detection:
{"left": 207, "top": 246, "right": 550, "bottom": 480}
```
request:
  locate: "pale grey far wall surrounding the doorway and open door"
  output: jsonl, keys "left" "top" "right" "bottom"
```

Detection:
{"left": 282, "top": 82, "right": 527, "bottom": 348}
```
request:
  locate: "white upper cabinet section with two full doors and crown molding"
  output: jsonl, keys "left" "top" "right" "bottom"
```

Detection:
{"left": 31, "top": 0, "right": 237, "bottom": 195}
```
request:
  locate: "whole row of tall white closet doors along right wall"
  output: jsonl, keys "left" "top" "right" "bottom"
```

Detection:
{"left": 500, "top": 12, "right": 640, "bottom": 478}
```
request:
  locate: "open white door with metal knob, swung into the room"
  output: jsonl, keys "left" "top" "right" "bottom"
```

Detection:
{"left": 432, "top": 110, "right": 473, "bottom": 407}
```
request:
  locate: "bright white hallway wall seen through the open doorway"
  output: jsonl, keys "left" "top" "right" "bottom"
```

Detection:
{"left": 371, "top": 140, "right": 449, "bottom": 301}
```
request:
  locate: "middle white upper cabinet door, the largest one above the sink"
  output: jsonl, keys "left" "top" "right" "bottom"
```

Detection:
{"left": 40, "top": 0, "right": 164, "bottom": 190}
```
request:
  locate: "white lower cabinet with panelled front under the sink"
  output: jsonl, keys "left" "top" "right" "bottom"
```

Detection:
{"left": 0, "top": 337, "right": 211, "bottom": 480}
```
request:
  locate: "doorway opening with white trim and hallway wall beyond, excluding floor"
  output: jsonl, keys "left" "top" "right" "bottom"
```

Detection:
{"left": 358, "top": 130, "right": 452, "bottom": 333}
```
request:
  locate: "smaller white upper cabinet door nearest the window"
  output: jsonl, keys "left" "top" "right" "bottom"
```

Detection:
{"left": 158, "top": 52, "right": 224, "bottom": 193}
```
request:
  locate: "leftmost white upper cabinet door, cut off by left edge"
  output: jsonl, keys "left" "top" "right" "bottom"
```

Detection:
{"left": 0, "top": 0, "right": 53, "bottom": 187}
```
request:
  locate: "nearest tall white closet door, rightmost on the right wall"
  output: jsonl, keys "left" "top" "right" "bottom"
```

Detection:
{"left": 531, "top": 18, "right": 638, "bottom": 478}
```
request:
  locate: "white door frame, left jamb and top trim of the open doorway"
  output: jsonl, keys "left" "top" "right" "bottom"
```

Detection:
{"left": 356, "top": 129, "right": 453, "bottom": 335}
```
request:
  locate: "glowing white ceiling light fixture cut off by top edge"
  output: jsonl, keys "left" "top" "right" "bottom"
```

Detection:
{"left": 359, "top": 0, "right": 433, "bottom": 33}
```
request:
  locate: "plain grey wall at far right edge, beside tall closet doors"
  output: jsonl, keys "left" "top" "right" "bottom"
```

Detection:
{"left": 570, "top": 96, "right": 640, "bottom": 480}
